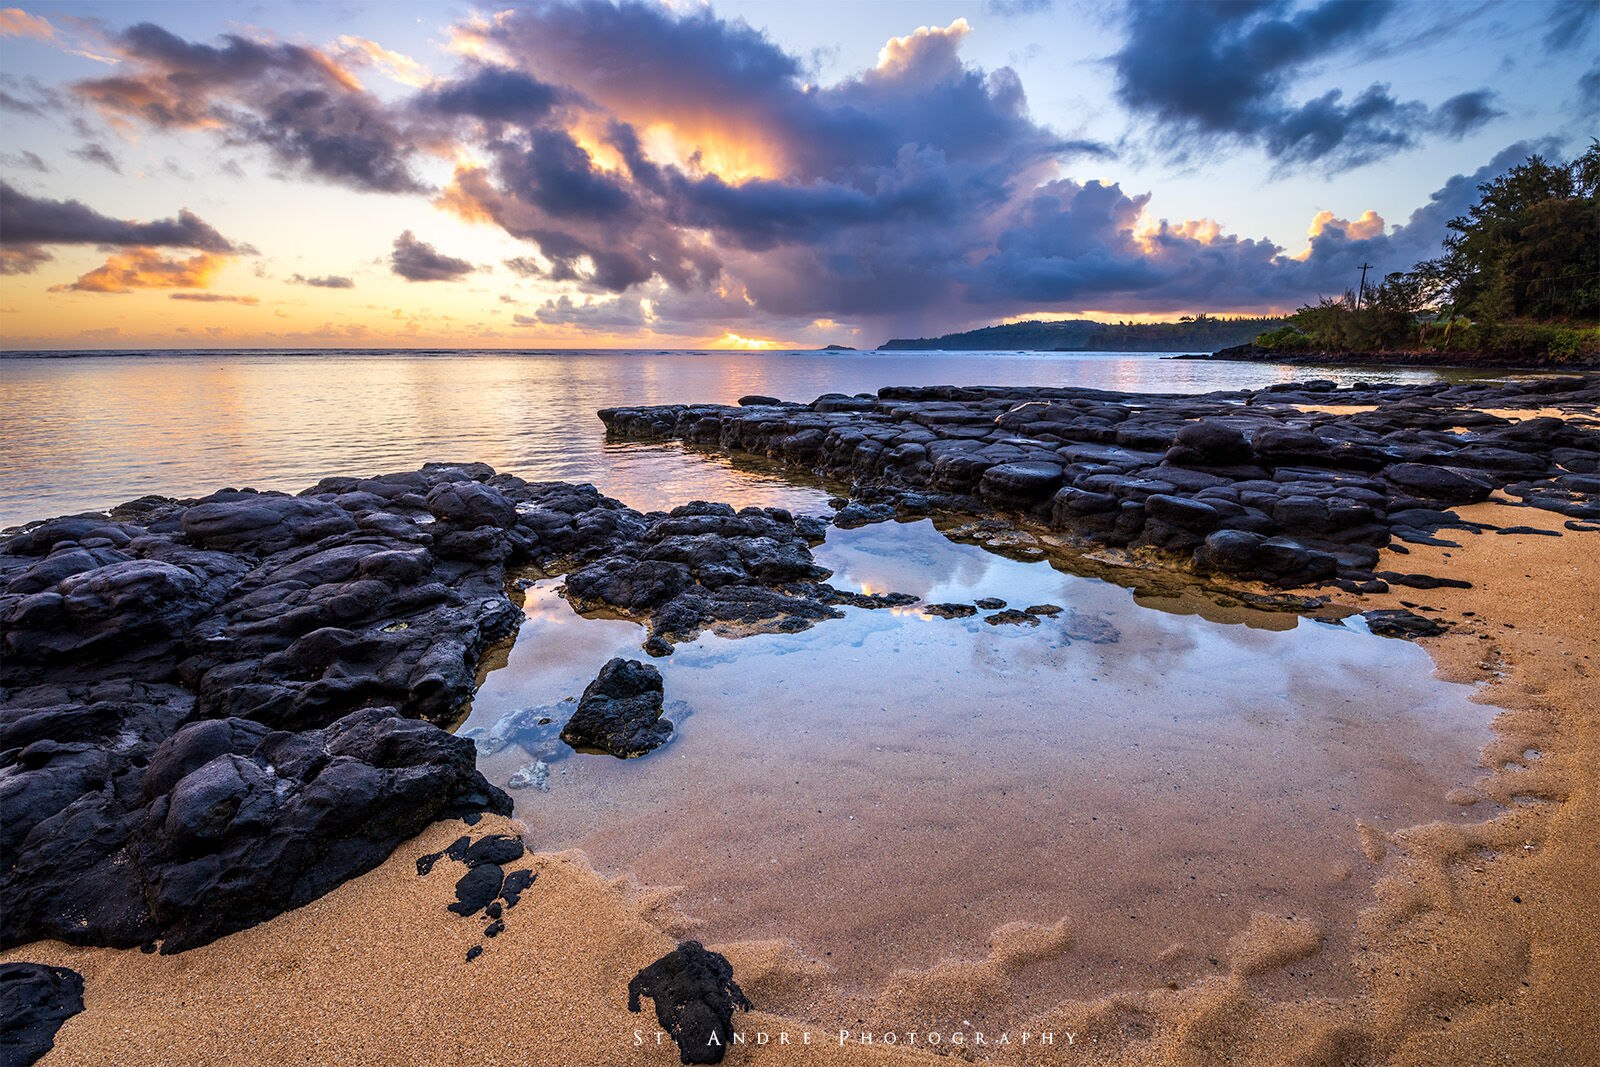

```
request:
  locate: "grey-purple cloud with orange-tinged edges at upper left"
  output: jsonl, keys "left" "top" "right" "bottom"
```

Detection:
{"left": 72, "top": 22, "right": 424, "bottom": 192}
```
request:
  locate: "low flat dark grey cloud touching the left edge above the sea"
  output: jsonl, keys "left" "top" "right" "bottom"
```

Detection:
{"left": 0, "top": 182, "right": 254, "bottom": 262}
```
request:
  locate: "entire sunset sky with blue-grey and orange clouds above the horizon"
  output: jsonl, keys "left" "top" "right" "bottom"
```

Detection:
{"left": 0, "top": 0, "right": 1600, "bottom": 349}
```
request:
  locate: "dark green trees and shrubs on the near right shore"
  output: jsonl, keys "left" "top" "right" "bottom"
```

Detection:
{"left": 1254, "top": 141, "right": 1600, "bottom": 363}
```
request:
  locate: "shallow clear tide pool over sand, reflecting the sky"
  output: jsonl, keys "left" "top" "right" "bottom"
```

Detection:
{"left": 466, "top": 520, "right": 1488, "bottom": 1025}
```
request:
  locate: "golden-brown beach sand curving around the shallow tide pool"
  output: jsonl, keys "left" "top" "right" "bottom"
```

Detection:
{"left": 5, "top": 504, "right": 1600, "bottom": 1067}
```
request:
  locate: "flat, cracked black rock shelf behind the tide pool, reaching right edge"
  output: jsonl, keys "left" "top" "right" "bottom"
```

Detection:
{"left": 598, "top": 374, "right": 1600, "bottom": 592}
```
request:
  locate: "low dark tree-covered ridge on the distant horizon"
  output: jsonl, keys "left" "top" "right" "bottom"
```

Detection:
{"left": 878, "top": 315, "right": 1283, "bottom": 352}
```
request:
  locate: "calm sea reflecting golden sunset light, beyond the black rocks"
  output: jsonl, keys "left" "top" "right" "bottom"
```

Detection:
{"left": 0, "top": 350, "right": 1472, "bottom": 526}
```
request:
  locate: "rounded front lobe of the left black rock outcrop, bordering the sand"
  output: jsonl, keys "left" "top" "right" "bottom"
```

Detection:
{"left": 0, "top": 709, "right": 510, "bottom": 952}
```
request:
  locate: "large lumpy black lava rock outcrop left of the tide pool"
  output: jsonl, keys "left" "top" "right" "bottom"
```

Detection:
{"left": 0, "top": 464, "right": 928, "bottom": 952}
